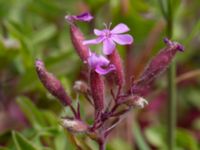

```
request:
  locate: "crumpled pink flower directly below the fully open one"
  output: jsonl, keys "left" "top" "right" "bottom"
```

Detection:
{"left": 87, "top": 53, "right": 115, "bottom": 75}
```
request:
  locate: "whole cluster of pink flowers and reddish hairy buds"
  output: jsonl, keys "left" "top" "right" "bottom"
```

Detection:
{"left": 35, "top": 13, "right": 184, "bottom": 150}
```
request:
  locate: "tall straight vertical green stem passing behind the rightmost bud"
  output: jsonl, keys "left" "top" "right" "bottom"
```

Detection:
{"left": 167, "top": 0, "right": 176, "bottom": 150}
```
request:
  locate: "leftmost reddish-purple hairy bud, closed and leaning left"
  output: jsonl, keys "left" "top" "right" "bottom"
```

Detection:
{"left": 35, "top": 60, "right": 71, "bottom": 106}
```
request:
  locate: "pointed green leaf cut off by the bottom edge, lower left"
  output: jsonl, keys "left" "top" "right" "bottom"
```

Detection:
{"left": 12, "top": 131, "right": 39, "bottom": 150}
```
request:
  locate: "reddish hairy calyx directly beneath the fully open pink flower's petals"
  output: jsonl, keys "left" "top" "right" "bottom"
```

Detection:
{"left": 108, "top": 50, "right": 124, "bottom": 86}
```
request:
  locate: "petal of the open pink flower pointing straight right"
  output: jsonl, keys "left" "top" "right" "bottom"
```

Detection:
{"left": 111, "top": 34, "right": 133, "bottom": 45}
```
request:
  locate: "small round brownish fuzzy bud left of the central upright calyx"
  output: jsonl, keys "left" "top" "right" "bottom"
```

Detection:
{"left": 73, "top": 80, "right": 89, "bottom": 93}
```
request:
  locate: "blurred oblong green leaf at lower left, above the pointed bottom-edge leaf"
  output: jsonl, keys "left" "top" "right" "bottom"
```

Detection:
{"left": 17, "top": 96, "right": 46, "bottom": 129}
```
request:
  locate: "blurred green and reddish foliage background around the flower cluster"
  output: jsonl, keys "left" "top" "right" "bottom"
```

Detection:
{"left": 0, "top": 0, "right": 200, "bottom": 150}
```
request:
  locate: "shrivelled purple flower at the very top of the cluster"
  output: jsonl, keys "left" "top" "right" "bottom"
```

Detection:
{"left": 65, "top": 12, "right": 93, "bottom": 22}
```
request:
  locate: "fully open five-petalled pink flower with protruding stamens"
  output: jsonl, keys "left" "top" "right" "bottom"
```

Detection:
{"left": 83, "top": 23, "right": 133, "bottom": 55}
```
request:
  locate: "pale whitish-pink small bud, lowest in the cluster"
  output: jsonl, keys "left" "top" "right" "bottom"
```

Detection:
{"left": 60, "top": 119, "right": 88, "bottom": 133}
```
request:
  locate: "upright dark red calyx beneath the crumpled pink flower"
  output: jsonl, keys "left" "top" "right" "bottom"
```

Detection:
{"left": 90, "top": 69, "right": 104, "bottom": 114}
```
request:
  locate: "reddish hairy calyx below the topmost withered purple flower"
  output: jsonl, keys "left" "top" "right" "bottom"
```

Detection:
{"left": 70, "top": 24, "right": 89, "bottom": 61}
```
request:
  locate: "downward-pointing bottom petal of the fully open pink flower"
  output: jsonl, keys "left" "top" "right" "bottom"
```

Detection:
{"left": 103, "top": 39, "right": 115, "bottom": 55}
